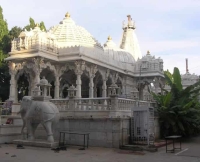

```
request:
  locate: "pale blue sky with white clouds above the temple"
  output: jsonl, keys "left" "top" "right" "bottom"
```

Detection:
{"left": 0, "top": 0, "right": 200, "bottom": 75}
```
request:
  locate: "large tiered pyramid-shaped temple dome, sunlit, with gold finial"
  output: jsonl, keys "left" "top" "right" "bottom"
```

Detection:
{"left": 49, "top": 13, "right": 101, "bottom": 47}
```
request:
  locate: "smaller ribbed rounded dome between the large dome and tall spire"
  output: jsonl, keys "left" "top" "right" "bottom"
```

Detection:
{"left": 104, "top": 36, "right": 135, "bottom": 64}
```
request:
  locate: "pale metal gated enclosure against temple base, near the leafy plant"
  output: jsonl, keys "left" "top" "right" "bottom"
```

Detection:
{"left": 131, "top": 107, "right": 155, "bottom": 145}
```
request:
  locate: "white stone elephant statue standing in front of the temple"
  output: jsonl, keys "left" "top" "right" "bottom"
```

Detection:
{"left": 19, "top": 96, "right": 60, "bottom": 142}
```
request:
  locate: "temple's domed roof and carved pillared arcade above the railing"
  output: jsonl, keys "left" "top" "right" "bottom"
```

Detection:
{"left": 6, "top": 13, "right": 164, "bottom": 103}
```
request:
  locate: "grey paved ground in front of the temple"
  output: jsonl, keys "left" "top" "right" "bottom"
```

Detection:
{"left": 0, "top": 137, "right": 200, "bottom": 162}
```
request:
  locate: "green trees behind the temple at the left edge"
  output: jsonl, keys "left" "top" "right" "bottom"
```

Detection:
{"left": 0, "top": 6, "right": 46, "bottom": 101}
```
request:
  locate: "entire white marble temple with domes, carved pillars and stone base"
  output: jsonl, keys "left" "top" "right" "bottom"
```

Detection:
{"left": 0, "top": 13, "right": 172, "bottom": 147}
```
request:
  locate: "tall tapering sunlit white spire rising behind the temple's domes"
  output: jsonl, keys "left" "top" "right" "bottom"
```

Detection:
{"left": 120, "top": 15, "right": 142, "bottom": 60}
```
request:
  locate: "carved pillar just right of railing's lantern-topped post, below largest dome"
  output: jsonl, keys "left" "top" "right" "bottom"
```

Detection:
{"left": 75, "top": 61, "right": 85, "bottom": 98}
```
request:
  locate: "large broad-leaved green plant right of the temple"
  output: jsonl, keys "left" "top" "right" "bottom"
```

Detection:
{"left": 152, "top": 67, "right": 200, "bottom": 136}
